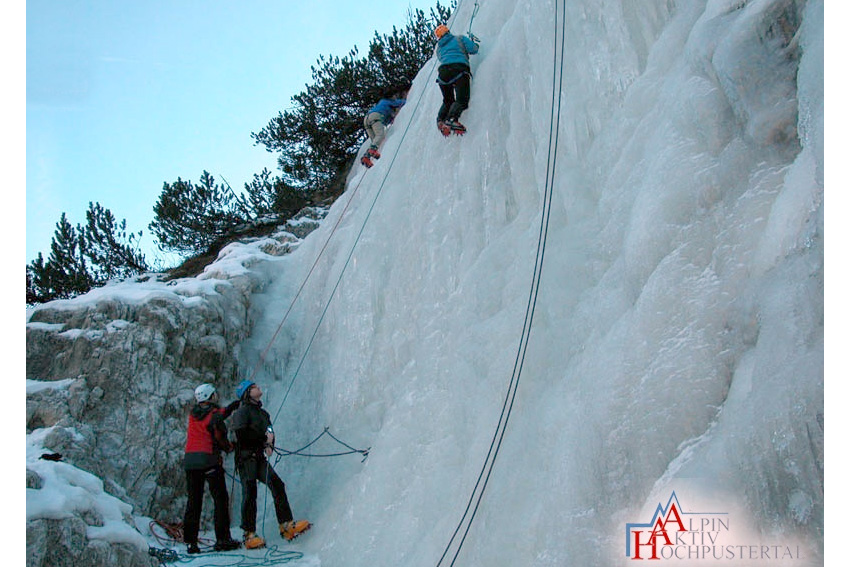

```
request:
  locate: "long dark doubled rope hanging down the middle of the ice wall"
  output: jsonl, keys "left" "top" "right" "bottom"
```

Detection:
{"left": 437, "top": 0, "right": 566, "bottom": 567}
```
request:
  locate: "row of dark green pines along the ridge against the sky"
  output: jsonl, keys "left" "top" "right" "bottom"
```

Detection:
{"left": 27, "top": 1, "right": 456, "bottom": 303}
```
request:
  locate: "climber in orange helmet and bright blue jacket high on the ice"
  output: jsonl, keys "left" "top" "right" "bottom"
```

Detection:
{"left": 434, "top": 24, "right": 478, "bottom": 136}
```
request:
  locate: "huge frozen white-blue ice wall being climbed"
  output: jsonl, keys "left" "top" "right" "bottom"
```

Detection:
{"left": 235, "top": 0, "right": 824, "bottom": 567}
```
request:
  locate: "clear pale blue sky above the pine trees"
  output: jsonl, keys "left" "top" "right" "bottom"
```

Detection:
{"left": 26, "top": 0, "right": 440, "bottom": 262}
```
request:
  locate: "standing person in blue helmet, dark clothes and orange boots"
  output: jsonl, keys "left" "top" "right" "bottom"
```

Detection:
{"left": 231, "top": 380, "right": 311, "bottom": 549}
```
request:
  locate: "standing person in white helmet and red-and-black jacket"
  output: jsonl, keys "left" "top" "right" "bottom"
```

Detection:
{"left": 183, "top": 384, "right": 239, "bottom": 553}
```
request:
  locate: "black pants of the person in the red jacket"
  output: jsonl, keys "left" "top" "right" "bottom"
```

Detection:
{"left": 183, "top": 466, "right": 230, "bottom": 543}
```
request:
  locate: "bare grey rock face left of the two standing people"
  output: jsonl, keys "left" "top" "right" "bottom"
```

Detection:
{"left": 27, "top": 282, "right": 253, "bottom": 514}
